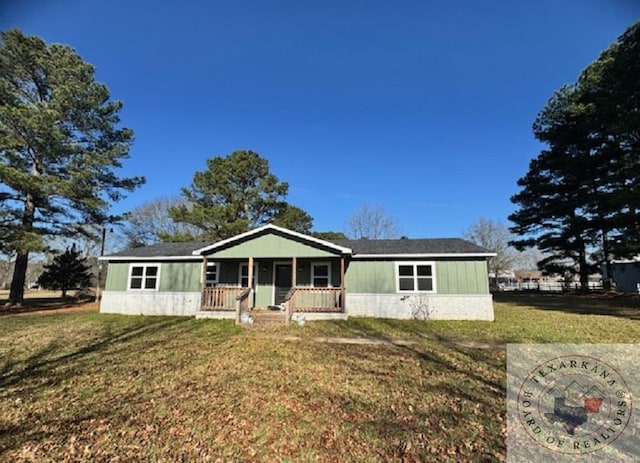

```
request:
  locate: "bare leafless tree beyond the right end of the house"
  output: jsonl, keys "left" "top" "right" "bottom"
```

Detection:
{"left": 462, "top": 217, "right": 521, "bottom": 278}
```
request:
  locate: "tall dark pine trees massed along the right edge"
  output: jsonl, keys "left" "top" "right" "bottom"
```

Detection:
{"left": 509, "top": 23, "right": 640, "bottom": 289}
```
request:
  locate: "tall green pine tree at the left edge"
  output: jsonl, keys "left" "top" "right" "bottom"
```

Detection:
{"left": 0, "top": 30, "right": 144, "bottom": 304}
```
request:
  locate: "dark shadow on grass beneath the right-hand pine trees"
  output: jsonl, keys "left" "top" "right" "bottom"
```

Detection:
{"left": 493, "top": 292, "right": 640, "bottom": 320}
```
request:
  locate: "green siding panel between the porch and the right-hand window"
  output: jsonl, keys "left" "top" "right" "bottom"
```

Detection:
{"left": 345, "top": 261, "right": 396, "bottom": 294}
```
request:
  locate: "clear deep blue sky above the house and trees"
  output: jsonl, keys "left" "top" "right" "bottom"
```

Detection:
{"left": 0, "top": 0, "right": 640, "bottom": 238}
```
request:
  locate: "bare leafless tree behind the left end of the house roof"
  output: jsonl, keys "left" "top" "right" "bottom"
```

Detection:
{"left": 122, "top": 197, "right": 202, "bottom": 248}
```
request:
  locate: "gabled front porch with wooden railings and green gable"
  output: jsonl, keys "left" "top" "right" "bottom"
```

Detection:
{"left": 194, "top": 225, "right": 352, "bottom": 322}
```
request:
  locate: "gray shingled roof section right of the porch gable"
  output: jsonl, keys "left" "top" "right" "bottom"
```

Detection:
{"left": 333, "top": 238, "right": 490, "bottom": 255}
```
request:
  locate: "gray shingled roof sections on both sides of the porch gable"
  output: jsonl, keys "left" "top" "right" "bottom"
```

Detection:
{"left": 105, "top": 238, "right": 490, "bottom": 260}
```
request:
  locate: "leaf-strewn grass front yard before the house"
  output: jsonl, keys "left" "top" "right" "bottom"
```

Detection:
{"left": 0, "top": 295, "right": 640, "bottom": 462}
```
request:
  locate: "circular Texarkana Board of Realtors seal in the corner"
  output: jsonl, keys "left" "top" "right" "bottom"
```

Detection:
{"left": 517, "top": 355, "right": 632, "bottom": 455}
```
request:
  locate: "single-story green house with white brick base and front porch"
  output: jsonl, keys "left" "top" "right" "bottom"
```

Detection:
{"left": 100, "top": 225, "right": 494, "bottom": 320}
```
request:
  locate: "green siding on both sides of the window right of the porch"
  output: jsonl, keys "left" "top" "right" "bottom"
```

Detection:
{"left": 345, "top": 260, "right": 489, "bottom": 294}
